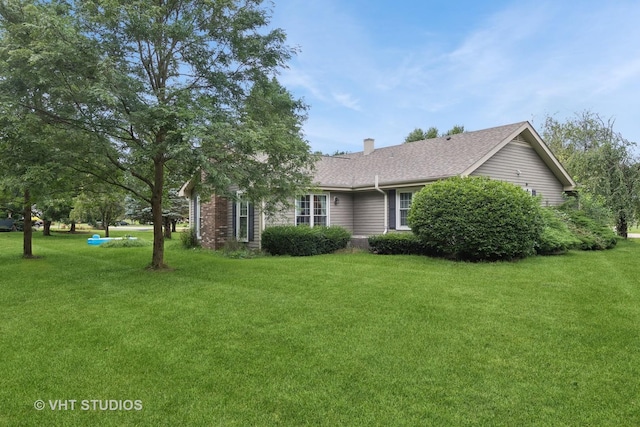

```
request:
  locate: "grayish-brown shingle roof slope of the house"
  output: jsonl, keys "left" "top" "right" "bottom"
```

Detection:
{"left": 314, "top": 122, "right": 530, "bottom": 188}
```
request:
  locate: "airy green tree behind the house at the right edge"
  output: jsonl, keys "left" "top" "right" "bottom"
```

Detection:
{"left": 542, "top": 111, "right": 640, "bottom": 238}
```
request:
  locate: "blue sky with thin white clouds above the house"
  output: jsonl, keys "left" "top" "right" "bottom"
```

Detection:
{"left": 271, "top": 0, "right": 640, "bottom": 154}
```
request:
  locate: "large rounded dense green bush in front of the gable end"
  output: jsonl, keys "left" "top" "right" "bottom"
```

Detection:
{"left": 408, "top": 177, "right": 542, "bottom": 261}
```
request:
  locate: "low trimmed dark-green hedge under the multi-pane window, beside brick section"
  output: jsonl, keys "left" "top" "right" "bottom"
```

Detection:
{"left": 262, "top": 225, "right": 351, "bottom": 256}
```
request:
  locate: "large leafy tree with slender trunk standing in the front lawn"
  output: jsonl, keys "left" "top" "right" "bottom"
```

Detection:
{"left": 0, "top": 0, "right": 313, "bottom": 269}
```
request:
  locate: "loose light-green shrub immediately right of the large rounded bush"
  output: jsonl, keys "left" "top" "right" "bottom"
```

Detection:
{"left": 536, "top": 208, "right": 581, "bottom": 255}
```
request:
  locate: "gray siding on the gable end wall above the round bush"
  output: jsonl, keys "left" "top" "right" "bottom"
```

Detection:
{"left": 471, "top": 141, "right": 563, "bottom": 205}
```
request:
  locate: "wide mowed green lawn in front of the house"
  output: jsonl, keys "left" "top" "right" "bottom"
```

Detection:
{"left": 0, "top": 231, "right": 640, "bottom": 426}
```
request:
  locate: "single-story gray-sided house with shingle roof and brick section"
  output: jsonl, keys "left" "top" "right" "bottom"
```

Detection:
{"left": 182, "top": 122, "right": 575, "bottom": 249}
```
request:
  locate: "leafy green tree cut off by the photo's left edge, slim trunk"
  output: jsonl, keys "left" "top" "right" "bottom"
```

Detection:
{"left": 0, "top": 1, "right": 90, "bottom": 258}
